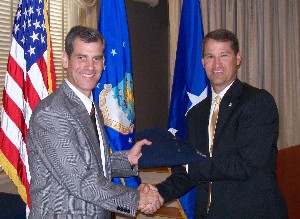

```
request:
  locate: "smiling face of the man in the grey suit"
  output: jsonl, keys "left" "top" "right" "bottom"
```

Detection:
{"left": 62, "top": 38, "right": 104, "bottom": 97}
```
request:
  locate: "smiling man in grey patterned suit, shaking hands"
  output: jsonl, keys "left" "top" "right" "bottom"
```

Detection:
{"left": 27, "top": 26, "right": 159, "bottom": 219}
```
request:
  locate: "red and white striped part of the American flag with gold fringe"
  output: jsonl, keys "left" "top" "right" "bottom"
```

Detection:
{"left": 0, "top": 0, "right": 56, "bottom": 210}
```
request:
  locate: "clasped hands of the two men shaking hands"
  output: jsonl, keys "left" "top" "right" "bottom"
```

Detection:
{"left": 138, "top": 183, "right": 164, "bottom": 214}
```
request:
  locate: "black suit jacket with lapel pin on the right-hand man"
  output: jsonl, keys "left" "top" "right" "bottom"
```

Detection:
{"left": 157, "top": 80, "right": 287, "bottom": 219}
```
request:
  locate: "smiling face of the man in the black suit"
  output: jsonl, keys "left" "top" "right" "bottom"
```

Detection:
{"left": 202, "top": 39, "right": 241, "bottom": 94}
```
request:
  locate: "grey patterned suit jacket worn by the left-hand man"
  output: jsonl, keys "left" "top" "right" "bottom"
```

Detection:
{"left": 27, "top": 82, "right": 139, "bottom": 219}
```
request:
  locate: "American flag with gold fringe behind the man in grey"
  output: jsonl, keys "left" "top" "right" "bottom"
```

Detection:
{"left": 0, "top": 0, "right": 56, "bottom": 207}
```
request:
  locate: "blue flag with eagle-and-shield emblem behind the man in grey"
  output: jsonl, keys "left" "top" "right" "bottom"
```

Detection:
{"left": 93, "top": 0, "right": 140, "bottom": 188}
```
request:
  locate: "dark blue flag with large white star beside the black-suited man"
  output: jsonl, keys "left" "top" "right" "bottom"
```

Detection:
{"left": 168, "top": 0, "right": 210, "bottom": 219}
